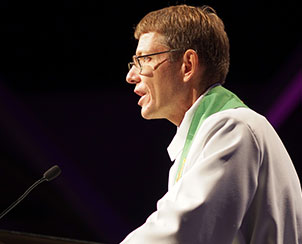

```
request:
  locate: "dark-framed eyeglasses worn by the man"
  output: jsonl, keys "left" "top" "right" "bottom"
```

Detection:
{"left": 128, "top": 49, "right": 181, "bottom": 74}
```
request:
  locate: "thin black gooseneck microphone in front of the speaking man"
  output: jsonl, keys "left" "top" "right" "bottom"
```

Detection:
{"left": 0, "top": 165, "right": 61, "bottom": 219}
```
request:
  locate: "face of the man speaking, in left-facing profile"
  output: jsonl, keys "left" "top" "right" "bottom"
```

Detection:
{"left": 126, "top": 32, "right": 182, "bottom": 121}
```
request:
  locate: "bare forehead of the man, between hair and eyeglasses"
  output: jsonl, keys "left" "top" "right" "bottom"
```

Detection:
{"left": 136, "top": 32, "right": 166, "bottom": 55}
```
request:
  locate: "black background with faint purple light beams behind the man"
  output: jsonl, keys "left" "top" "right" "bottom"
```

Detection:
{"left": 0, "top": 0, "right": 302, "bottom": 243}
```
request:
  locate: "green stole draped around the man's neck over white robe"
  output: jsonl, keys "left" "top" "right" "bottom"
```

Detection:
{"left": 175, "top": 85, "right": 247, "bottom": 182}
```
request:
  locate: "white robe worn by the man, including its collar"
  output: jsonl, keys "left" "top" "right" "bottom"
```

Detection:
{"left": 122, "top": 89, "right": 302, "bottom": 244}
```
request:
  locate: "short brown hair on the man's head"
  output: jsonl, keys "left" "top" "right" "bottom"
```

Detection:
{"left": 134, "top": 5, "right": 230, "bottom": 85}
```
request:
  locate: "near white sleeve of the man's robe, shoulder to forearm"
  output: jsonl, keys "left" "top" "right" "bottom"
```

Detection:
{"left": 122, "top": 115, "right": 261, "bottom": 244}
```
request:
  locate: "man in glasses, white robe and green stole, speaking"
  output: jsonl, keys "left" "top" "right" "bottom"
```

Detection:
{"left": 122, "top": 5, "right": 302, "bottom": 244}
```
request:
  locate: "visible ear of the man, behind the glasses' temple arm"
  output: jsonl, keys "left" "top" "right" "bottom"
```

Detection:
{"left": 182, "top": 49, "right": 199, "bottom": 82}
